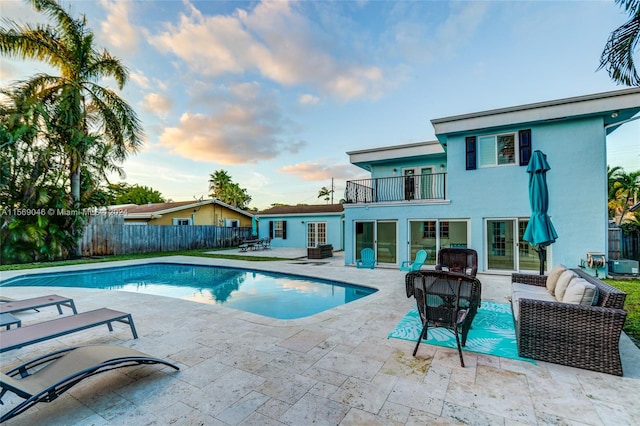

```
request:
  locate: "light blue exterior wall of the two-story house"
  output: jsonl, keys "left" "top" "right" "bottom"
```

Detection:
{"left": 345, "top": 116, "right": 607, "bottom": 271}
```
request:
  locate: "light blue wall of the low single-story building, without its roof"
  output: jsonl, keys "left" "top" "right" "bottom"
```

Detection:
{"left": 258, "top": 214, "right": 343, "bottom": 250}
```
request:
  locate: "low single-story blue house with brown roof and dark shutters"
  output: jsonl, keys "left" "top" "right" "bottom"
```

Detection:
{"left": 255, "top": 204, "right": 344, "bottom": 250}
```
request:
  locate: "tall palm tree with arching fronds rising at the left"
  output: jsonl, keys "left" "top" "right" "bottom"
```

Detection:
{"left": 0, "top": 0, "right": 143, "bottom": 205}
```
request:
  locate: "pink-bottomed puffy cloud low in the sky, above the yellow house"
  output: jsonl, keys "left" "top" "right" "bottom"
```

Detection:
{"left": 159, "top": 83, "right": 306, "bottom": 165}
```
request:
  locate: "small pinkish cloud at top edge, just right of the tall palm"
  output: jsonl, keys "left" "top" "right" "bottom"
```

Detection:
{"left": 100, "top": 0, "right": 139, "bottom": 53}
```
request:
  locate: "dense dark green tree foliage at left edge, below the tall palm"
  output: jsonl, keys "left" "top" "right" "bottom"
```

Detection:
{"left": 0, "top": 91, "right": 83, "bottom": 264}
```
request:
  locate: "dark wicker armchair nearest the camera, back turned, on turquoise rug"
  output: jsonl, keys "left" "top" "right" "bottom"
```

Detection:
{"left": 405, "top": 271, "right": 482, "bottom": 367}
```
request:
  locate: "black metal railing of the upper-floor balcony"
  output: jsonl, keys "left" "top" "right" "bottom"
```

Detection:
{"left": 344, "top": 173, "right": 446, "bottom": 203}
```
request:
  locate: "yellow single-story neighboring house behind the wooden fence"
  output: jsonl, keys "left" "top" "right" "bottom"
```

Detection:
{"left": 114, "top": 198, "right": 253, "bottom": 228}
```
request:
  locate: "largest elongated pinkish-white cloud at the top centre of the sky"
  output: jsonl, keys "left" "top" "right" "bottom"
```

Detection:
{"left": 149, "top": 1, "right": 388, "bottom": 100}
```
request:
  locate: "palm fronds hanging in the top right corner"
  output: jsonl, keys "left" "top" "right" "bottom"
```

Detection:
{"left": 598, "top": 0, "right": 640, "bottom": 86}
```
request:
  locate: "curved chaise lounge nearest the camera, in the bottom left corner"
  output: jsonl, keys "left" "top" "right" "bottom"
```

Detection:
{"left": 0, "top": 345, "right": 180, "bottom": 423}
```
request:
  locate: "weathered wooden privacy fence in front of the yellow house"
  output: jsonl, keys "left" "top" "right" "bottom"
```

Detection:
{"left": 80, "top": 215, "right": 251, "bottom": 256}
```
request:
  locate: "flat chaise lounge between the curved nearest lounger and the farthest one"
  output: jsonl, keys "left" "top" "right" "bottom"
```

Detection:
{"left": 0, "top": 308, "right": 138, "bottom": 353}
